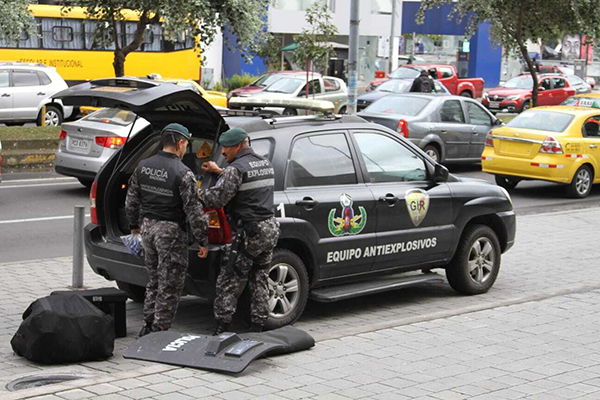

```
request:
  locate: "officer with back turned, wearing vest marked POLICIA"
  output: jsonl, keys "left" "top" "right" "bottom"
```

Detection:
{"left": 125, "top": 124, "right": 208, "bottom": 337}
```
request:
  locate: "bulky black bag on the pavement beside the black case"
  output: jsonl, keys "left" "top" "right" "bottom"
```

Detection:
{"left": 10, "top": 294, "right": 115, "bottom": 364}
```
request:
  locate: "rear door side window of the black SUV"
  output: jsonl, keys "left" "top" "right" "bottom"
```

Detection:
{"left": 286, "top": 133, "right": 358, "bottom": 188}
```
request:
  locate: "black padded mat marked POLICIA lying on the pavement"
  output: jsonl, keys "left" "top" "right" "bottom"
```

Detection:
{"left": 123, "top": 326, "right": 315, "bottom": 374}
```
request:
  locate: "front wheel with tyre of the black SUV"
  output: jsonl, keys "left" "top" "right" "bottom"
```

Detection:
{"left": 446, "top": 225, "right": 501, "bottom": 295}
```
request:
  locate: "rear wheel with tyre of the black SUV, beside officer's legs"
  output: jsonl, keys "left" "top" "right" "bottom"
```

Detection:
{"left": 239, "top": 249, "right": 308, "bottom": 330}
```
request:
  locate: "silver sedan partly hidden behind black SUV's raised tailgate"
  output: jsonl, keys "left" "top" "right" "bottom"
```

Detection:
{"left": 54, "top": 108, "right": 150, "bottom": 186}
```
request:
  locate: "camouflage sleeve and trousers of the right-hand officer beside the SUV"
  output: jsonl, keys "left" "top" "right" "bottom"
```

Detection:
{"left": 200, "top": 156, "right": 279, "bottom": 325}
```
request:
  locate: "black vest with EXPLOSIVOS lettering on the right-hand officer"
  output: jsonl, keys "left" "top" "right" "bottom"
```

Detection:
{"left": 227, "top": 148, "right": 275, "bottom": 223}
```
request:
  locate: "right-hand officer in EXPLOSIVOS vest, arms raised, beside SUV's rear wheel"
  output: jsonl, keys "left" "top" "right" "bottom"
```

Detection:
{"left": 200, "top": 128, "right": 279, "bottom": 335}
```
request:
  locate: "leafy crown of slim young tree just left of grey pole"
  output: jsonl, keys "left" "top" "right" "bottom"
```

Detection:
{"left": 293, "top": 1, "right": 338, "bottom": 70}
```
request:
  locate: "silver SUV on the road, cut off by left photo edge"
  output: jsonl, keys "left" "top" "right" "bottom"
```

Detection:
{"left": 0, "top": 62, "right": 73, "bottom": 126}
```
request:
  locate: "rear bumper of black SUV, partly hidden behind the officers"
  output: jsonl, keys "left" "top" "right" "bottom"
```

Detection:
{"left": 84, "top": 224, "right": 221, "bottom": 299}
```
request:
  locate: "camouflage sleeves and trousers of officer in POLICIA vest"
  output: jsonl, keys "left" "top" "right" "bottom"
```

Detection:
{"left": 125, "top": 159, "right": 208, "bottom": 332}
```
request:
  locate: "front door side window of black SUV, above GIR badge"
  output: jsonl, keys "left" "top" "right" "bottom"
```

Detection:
{"left": 354, "top": 132, "right": 427, "bottom": 183}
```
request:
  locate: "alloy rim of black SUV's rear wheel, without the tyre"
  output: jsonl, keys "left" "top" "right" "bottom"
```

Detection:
{"left": 267, "top": 263, "right": 300, "bottom": 319}
